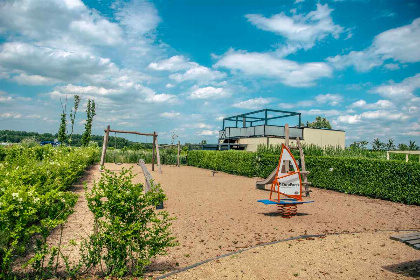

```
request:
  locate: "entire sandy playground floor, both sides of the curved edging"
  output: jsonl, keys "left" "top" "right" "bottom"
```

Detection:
{"left": 44, "top": 163, "right": 420, "bottom": 279}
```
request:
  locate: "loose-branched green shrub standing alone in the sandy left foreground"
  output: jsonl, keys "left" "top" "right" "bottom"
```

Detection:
{"left": 82, "top": 169, "right": 176, "bottom": 276}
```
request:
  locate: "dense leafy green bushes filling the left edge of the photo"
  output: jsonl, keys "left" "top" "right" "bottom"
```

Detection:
{"left": 0, "top": 145, "right": 98, "bottom": 279}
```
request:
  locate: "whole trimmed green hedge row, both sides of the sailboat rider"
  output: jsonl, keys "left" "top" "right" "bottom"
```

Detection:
{"left": 188, "top": 151, "right": 420, "bottom": 205}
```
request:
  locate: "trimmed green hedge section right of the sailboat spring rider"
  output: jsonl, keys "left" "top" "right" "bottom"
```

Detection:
{"left": 306, "top": 157, "right": 420, "bottom": 205}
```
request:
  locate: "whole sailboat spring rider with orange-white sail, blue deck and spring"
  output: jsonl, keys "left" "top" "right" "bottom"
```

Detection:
{"left": 257, "top": 143, "right": 313, "bottom": 218}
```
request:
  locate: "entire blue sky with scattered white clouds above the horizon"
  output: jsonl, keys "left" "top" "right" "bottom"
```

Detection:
{"left": 0, "top": 0, "right": 420, "bottom": 146}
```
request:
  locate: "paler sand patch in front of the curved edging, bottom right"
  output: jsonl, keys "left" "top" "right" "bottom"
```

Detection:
{"left": 168, "top": 232, "right": 420, "bottom": 280}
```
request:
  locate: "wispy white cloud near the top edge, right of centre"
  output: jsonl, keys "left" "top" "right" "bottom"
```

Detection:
{"left": 245, "top": 4, "right": 343, "bottom": 49}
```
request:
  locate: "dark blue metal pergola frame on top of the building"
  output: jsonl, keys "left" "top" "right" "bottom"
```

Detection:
{"left": 222, "top": 109, "right": 302, "bottom": 130}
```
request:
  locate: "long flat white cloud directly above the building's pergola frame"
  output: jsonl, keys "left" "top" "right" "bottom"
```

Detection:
{"left": 215, "top": 50, "right": 332, "bottom": 87}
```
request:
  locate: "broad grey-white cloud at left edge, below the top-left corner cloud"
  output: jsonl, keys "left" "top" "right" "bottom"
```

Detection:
{"left": 0, "top": 42, "right": 146, "bottom": 88}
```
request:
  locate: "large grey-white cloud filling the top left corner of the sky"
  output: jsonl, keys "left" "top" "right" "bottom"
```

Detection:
{"left": 0, "top": 0, "right": 122, "bottom": 50}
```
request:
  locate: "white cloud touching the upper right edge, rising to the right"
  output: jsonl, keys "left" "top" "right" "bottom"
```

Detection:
{"left": 328, "top": 18, "right": 420, "bottom": 72}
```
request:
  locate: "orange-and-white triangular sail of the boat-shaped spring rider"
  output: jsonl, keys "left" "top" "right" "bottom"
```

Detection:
{"left": 270, "top": 144, "right": 302, "bottom": 201}
